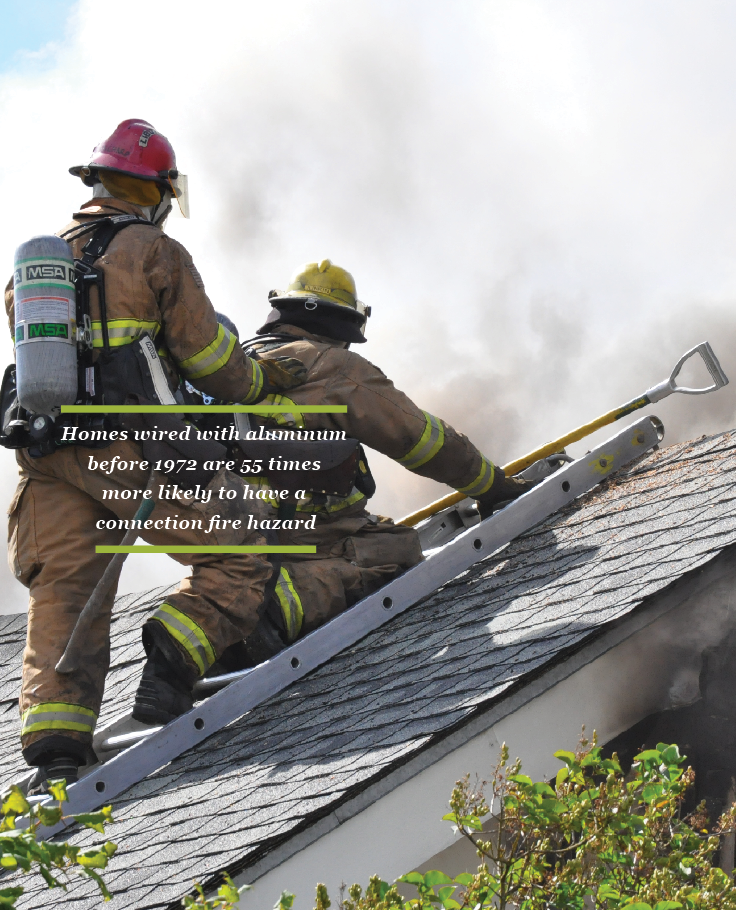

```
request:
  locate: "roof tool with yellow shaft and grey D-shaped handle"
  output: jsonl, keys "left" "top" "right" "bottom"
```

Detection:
{"left": 398, "top": 341, "right": 728, "bottom": 527}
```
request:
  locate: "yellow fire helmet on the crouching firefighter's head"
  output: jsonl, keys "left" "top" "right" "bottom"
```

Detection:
{"left": 259, "top": 259, "right": 371, "bottom": 344}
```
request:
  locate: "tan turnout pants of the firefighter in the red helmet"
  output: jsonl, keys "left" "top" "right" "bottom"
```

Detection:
{"left": 8, "top": 441, "right": 272, "bottom": 764}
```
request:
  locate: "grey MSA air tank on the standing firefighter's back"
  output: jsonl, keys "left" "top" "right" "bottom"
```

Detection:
{"left": 13, "top": 236, "right": 77, "bottom": 414}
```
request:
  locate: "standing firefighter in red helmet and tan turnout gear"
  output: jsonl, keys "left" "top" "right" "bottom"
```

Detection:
{"left": 5, "top": 119, "right": 303, "bottom": 783}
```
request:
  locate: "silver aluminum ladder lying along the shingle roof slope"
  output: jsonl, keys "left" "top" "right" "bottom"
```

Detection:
{"left": 34, "top": 417, "right": 664, "bottom": 837}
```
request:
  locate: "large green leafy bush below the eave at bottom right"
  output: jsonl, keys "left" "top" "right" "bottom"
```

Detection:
{"left": 315, "top": 739, "right": 736, "bottom": 910}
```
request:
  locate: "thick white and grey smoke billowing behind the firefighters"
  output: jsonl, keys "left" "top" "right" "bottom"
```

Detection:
{"left": 0, "top": 0, "right": 736, "bottom": 608}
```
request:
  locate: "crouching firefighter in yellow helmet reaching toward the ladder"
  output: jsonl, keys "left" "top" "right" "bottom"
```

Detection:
{"left": 222, "top": 259, "right": 530, "bottom": 670}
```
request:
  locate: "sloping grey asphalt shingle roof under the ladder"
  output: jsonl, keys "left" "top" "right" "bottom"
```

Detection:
{"left": 8, "top": 432, "right": 736, "bottom": 910}
